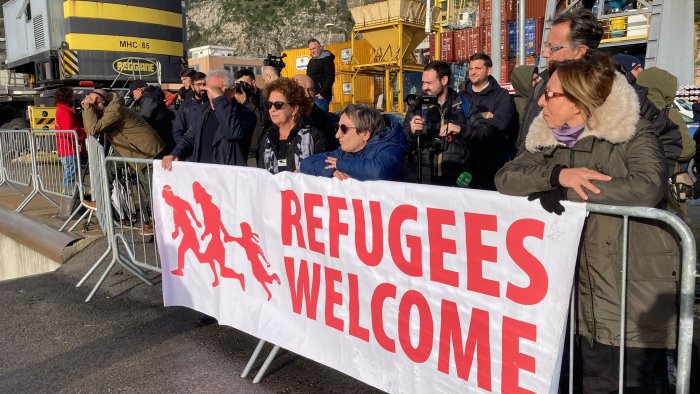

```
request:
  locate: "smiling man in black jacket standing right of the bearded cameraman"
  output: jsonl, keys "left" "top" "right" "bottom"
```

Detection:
{"left": 462, "top": 53, "right": 518, "bottom": 190}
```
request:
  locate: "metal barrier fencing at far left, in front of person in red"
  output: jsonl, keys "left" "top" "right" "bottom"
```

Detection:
{"left": 0, "top": 130, "right": 85, "bottom": 231}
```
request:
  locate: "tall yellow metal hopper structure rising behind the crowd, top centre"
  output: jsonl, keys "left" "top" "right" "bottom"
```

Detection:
{"left": 348, "top": 0, "right": 440, "bottom": 112}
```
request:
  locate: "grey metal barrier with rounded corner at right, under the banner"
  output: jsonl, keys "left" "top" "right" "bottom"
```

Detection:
{"left": 241, "top": 204, "right": 698, "bottom": 394}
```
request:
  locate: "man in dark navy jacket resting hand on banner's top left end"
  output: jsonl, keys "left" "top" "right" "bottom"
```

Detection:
{"left": 162, "top": 70, "right": 256, "bottom": 170}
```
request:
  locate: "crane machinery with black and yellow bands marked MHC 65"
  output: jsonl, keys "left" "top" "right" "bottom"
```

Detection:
{"left": 0, "top": 0, "right": 187, "bottom": 124}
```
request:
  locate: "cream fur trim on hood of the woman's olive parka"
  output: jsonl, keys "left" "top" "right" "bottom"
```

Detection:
{"left": 525, "top": 73, "right": 639, "bottom": 152}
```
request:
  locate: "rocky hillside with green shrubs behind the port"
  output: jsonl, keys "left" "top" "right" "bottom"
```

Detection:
{"left": 185, "top": 0, "right": 353, "bottom": 57}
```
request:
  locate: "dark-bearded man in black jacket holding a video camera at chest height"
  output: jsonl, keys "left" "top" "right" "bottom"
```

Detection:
{"left": 403, "top": 61, "right": 469, "bottom": 186}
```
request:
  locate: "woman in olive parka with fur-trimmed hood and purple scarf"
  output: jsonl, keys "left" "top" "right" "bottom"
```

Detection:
{"left": 495, "top": 53, "right": 679, "bottom": 393}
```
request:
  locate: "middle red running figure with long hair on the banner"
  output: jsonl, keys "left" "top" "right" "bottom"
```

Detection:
{"left": 192, "top": 182, "right": 245, "bottom": 290}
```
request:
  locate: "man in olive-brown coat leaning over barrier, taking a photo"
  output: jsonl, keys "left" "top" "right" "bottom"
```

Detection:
{"left": 81, "top": 89, "right": 165, "bottom": 159}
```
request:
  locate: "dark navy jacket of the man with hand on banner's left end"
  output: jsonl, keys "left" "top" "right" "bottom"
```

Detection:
{"left": 171, "top": 96, "right": 255, "bottom": 166}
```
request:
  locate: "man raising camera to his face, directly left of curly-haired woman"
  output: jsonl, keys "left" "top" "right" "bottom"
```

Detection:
{"left": 233, "top": 68, "right": 270, "bottom": 167}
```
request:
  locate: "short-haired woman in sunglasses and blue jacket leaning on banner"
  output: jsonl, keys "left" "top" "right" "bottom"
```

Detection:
{"left": 301, "top": 104, "right": 408, "bottom": 181}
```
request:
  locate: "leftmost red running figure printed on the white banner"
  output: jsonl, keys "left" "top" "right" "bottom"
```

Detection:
{"left": 162, "top": 185, "right": 202, "bottom": 276}
